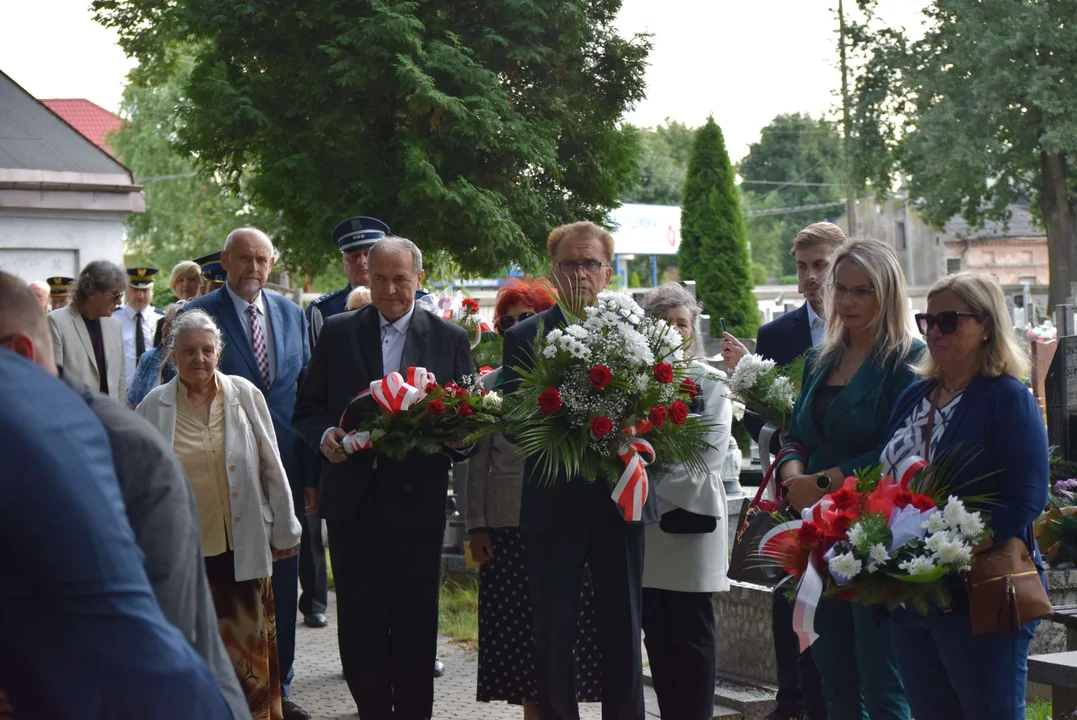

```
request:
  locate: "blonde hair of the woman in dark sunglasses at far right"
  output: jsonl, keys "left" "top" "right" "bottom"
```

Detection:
{"left": 914, "top": 272, "right": 1029, "bottom": 380}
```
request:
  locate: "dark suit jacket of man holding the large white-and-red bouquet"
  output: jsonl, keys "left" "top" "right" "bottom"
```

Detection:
{"left": 501, "top": 305, "right": 659, "bottom": 533}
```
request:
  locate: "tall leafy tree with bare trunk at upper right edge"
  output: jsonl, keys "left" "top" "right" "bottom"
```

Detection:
{"left": 854, "top": 0, "right": 1077, "bottom": 307}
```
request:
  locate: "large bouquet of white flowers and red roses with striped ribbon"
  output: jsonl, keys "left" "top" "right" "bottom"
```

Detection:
{"left": 505, "top": 292, "right": 710, "bottom": 521}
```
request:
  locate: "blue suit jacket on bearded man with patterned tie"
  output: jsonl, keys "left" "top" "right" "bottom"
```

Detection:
{"left": 180, "top": 287, "right": 310, "bottom": 488}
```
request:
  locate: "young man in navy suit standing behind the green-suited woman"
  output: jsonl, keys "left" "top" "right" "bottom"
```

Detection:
{"left": 722, "top": 223, "right": 845, "bottom": 720}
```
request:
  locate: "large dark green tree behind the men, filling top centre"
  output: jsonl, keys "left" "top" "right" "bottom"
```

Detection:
{"left": 93, "top": 0, "right": 649, "bottom": 273}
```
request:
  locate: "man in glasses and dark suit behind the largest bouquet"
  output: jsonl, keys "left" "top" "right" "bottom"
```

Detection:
{"left": 503, "top": 222, "right": 658, "bottom": 720}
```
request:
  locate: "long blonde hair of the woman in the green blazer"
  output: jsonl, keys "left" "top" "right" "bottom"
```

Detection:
{"left": 817, "top": 239, "right": 913, "bottom": 366}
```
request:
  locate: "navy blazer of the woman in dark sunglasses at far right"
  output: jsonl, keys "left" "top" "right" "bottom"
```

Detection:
{"left": 886, "top": 375, "right": 1050, "bottom": 546}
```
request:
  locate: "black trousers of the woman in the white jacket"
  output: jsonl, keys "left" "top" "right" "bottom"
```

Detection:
{"left": 643, "top": 588, "right": 718, "bottom": 720}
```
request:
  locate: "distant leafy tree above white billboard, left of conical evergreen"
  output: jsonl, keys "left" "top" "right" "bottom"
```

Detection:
{"left": 621, "top": 118, "right": 696, "bottom": 206}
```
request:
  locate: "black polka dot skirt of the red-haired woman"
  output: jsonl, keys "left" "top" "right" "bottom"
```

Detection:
{"left": 476, "top": 527, "right": 602, "bottom": 705}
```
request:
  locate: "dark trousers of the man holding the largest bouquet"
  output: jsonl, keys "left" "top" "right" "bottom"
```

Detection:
{"left": 527, "top": 513, "right": 644, "bottom": 720}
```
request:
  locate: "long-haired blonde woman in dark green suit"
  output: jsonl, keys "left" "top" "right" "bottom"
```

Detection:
{"left": 779, "top": 240, "right": 923, "bottom": 720}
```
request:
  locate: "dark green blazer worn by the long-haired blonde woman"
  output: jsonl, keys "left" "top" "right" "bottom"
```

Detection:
{"left": 783, "top": 340, "right": 924, "bottom": 477}
